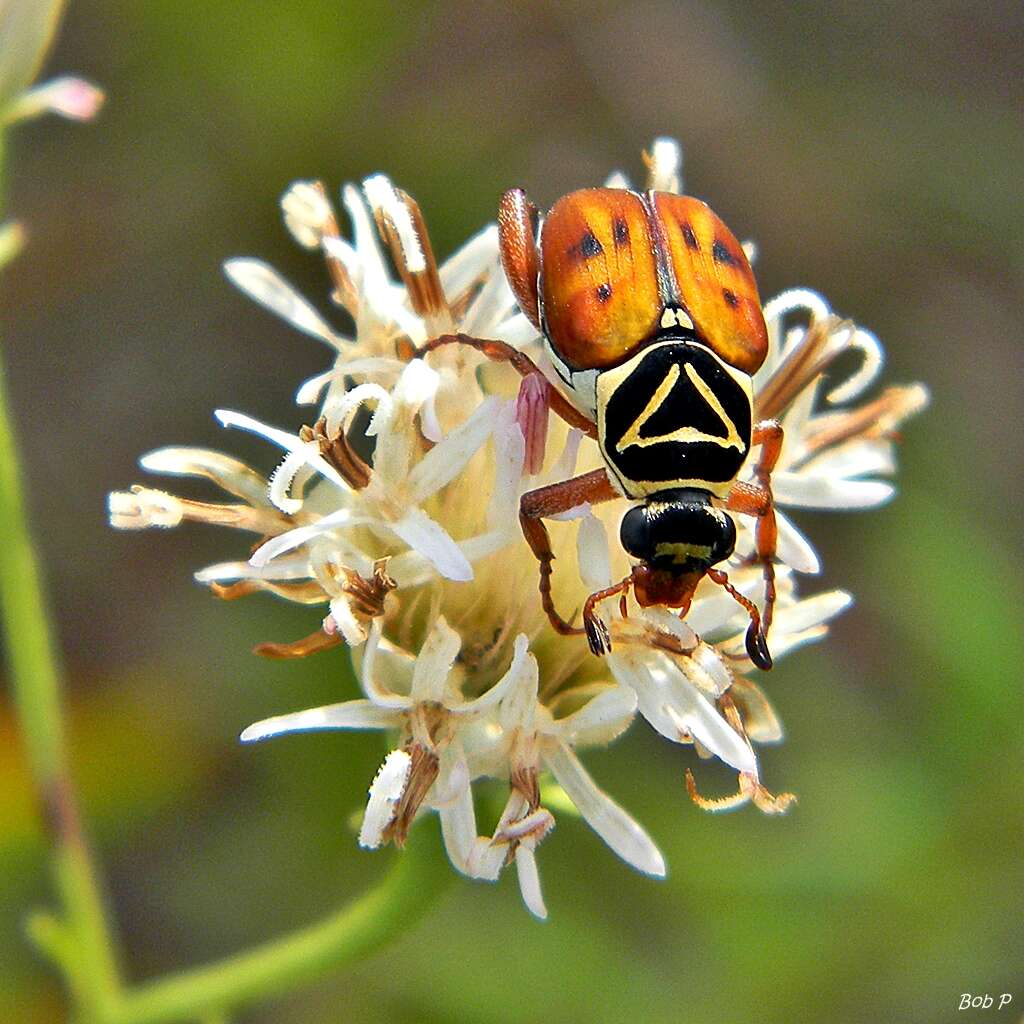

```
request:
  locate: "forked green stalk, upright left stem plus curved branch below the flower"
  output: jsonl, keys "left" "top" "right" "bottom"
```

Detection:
{"left": 0, "top": 137, "right": 452, "bottom": 1024}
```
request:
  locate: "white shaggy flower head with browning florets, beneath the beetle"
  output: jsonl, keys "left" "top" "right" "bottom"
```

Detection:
{"left": 110, "top": 139, "right": 928, "bottom": 918}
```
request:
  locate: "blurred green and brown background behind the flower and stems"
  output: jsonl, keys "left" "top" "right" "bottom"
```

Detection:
{"left": 0, "top": 0, "right": 1024, "bottom": 1024}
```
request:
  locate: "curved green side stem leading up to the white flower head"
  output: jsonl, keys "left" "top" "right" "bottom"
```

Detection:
{"left": 109, "top": 835, "right": 453, "bottom": 1024}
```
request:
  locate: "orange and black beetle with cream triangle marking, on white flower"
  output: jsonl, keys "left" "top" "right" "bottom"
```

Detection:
{"left": 419, "top": 187, "right": 782, "bottom": 670}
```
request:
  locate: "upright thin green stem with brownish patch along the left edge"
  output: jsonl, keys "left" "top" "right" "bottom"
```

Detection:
{"left": 0, "top": 140, "right": 118, "bottom": 1020}
